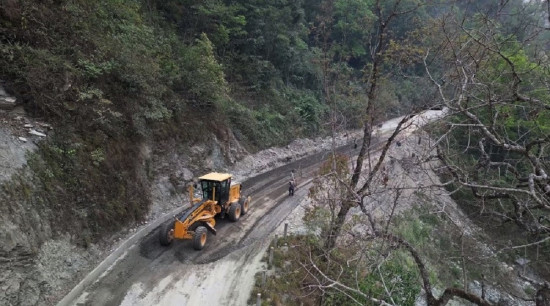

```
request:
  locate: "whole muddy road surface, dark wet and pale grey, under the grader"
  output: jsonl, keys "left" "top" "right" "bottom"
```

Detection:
{"left": 72, "top": 145, "right": 358, "bottom": 305}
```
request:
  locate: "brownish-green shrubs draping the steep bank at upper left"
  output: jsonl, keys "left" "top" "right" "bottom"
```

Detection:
{"left": 0, "top": 0, "right": 185, "bottom": 243}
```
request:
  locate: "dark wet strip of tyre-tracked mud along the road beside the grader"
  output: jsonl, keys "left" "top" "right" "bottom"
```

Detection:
{"left": 73, "top": 139, "right": 392, "bottom": 305}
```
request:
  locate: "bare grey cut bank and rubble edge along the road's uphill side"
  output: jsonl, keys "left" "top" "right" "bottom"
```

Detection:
{"left": 0, "top": 95, "right": 362, "bottom": 305}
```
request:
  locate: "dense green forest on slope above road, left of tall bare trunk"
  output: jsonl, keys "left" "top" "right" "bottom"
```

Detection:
{"left": 0, "top": 0, "right": 427, "bottom": 239}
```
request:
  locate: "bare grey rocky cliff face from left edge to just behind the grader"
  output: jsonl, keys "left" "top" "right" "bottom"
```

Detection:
{"left": 0, "top": 92, "right": 252, "bottom": 305}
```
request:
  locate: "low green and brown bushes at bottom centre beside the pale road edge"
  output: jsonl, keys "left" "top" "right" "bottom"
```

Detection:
{"left": 252, "top": 235, "right": 420, "bottom": 305}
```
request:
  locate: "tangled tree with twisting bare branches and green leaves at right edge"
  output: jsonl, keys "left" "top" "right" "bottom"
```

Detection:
{"left": 424, "top": 2, "right": 550, "bottom": 238}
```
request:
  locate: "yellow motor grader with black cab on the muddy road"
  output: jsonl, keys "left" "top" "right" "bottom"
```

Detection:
{"left": 159, "top": 172, "right": 250, "bottom": 250}
